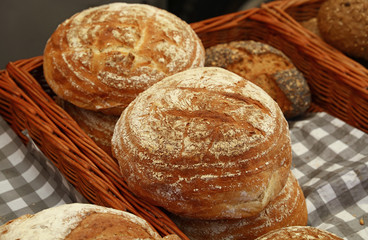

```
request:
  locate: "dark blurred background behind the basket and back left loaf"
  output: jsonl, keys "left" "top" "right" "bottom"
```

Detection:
{"left": 0, "top": 0, "right": 267, "bottom": 69}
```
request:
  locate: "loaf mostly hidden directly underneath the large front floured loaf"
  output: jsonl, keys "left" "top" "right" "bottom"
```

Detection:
{"left": 172, "top": 173, "right": 308, "bottom": 240}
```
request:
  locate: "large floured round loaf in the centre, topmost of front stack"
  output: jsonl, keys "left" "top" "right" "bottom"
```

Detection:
{"left": 112, "top": 67, "right": 291, "bottom": 219}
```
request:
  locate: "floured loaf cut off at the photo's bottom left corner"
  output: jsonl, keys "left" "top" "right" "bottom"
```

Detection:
{"left": 0, "top": 203, "right": 180, "bottom": 240}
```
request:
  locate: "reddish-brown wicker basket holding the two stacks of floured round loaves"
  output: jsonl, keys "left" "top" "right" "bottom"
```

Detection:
{"left": 0, "top": 4, "right": 368, "bottom": 239}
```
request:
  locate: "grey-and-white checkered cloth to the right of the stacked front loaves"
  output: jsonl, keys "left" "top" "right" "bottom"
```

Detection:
{"left": 289, "top": 113, "right": 368, "bottom": 240}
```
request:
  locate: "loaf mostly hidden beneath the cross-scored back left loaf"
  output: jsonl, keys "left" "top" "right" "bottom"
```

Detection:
{"left": 57, "top": 98, "right": 119, "bottom": 156}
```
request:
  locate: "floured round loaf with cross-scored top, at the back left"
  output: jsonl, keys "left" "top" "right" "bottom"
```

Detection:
{"left": 44, "top": 3, "right": 205, "bottom": 115}
